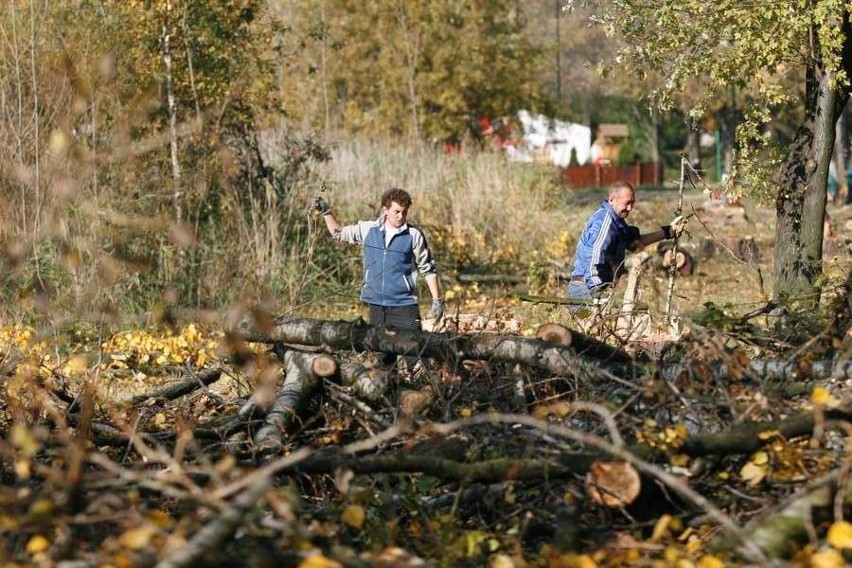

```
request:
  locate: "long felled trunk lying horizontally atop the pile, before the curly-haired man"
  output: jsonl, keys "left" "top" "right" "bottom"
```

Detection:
{"left": 229, "top": 318, "right": 632, "bottom": 379}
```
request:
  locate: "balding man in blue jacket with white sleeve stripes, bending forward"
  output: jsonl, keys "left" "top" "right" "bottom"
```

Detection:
{"left": 566, "top": 181, "right": 686, "bottom": 299}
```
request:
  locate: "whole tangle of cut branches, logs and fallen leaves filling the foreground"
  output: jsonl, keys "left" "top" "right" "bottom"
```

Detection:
{"left": 0, "top": 298, "right": 852, "bottom": 566}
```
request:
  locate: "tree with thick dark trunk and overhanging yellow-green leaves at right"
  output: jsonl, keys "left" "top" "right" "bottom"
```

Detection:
{"left": 599, "top": 0, "right": 852, "bottom": 305}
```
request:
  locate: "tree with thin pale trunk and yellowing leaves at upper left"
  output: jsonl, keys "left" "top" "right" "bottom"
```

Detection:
{"left": 103, "top": 0, "right": 275, "bottom": 222}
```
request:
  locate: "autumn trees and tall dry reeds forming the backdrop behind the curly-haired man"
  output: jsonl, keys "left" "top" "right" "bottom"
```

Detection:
{"left": 0, "top": 0, "right": 760, "bottom": 317}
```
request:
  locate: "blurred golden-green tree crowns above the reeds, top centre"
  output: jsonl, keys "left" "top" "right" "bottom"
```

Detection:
{"left": 276, "top": 0, "right": 542, "bottom": 139}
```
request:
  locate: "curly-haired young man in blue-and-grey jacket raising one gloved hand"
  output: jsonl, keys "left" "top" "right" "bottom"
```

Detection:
{"left": 314, "top": 188, "right": 444, "bottom": 372}
